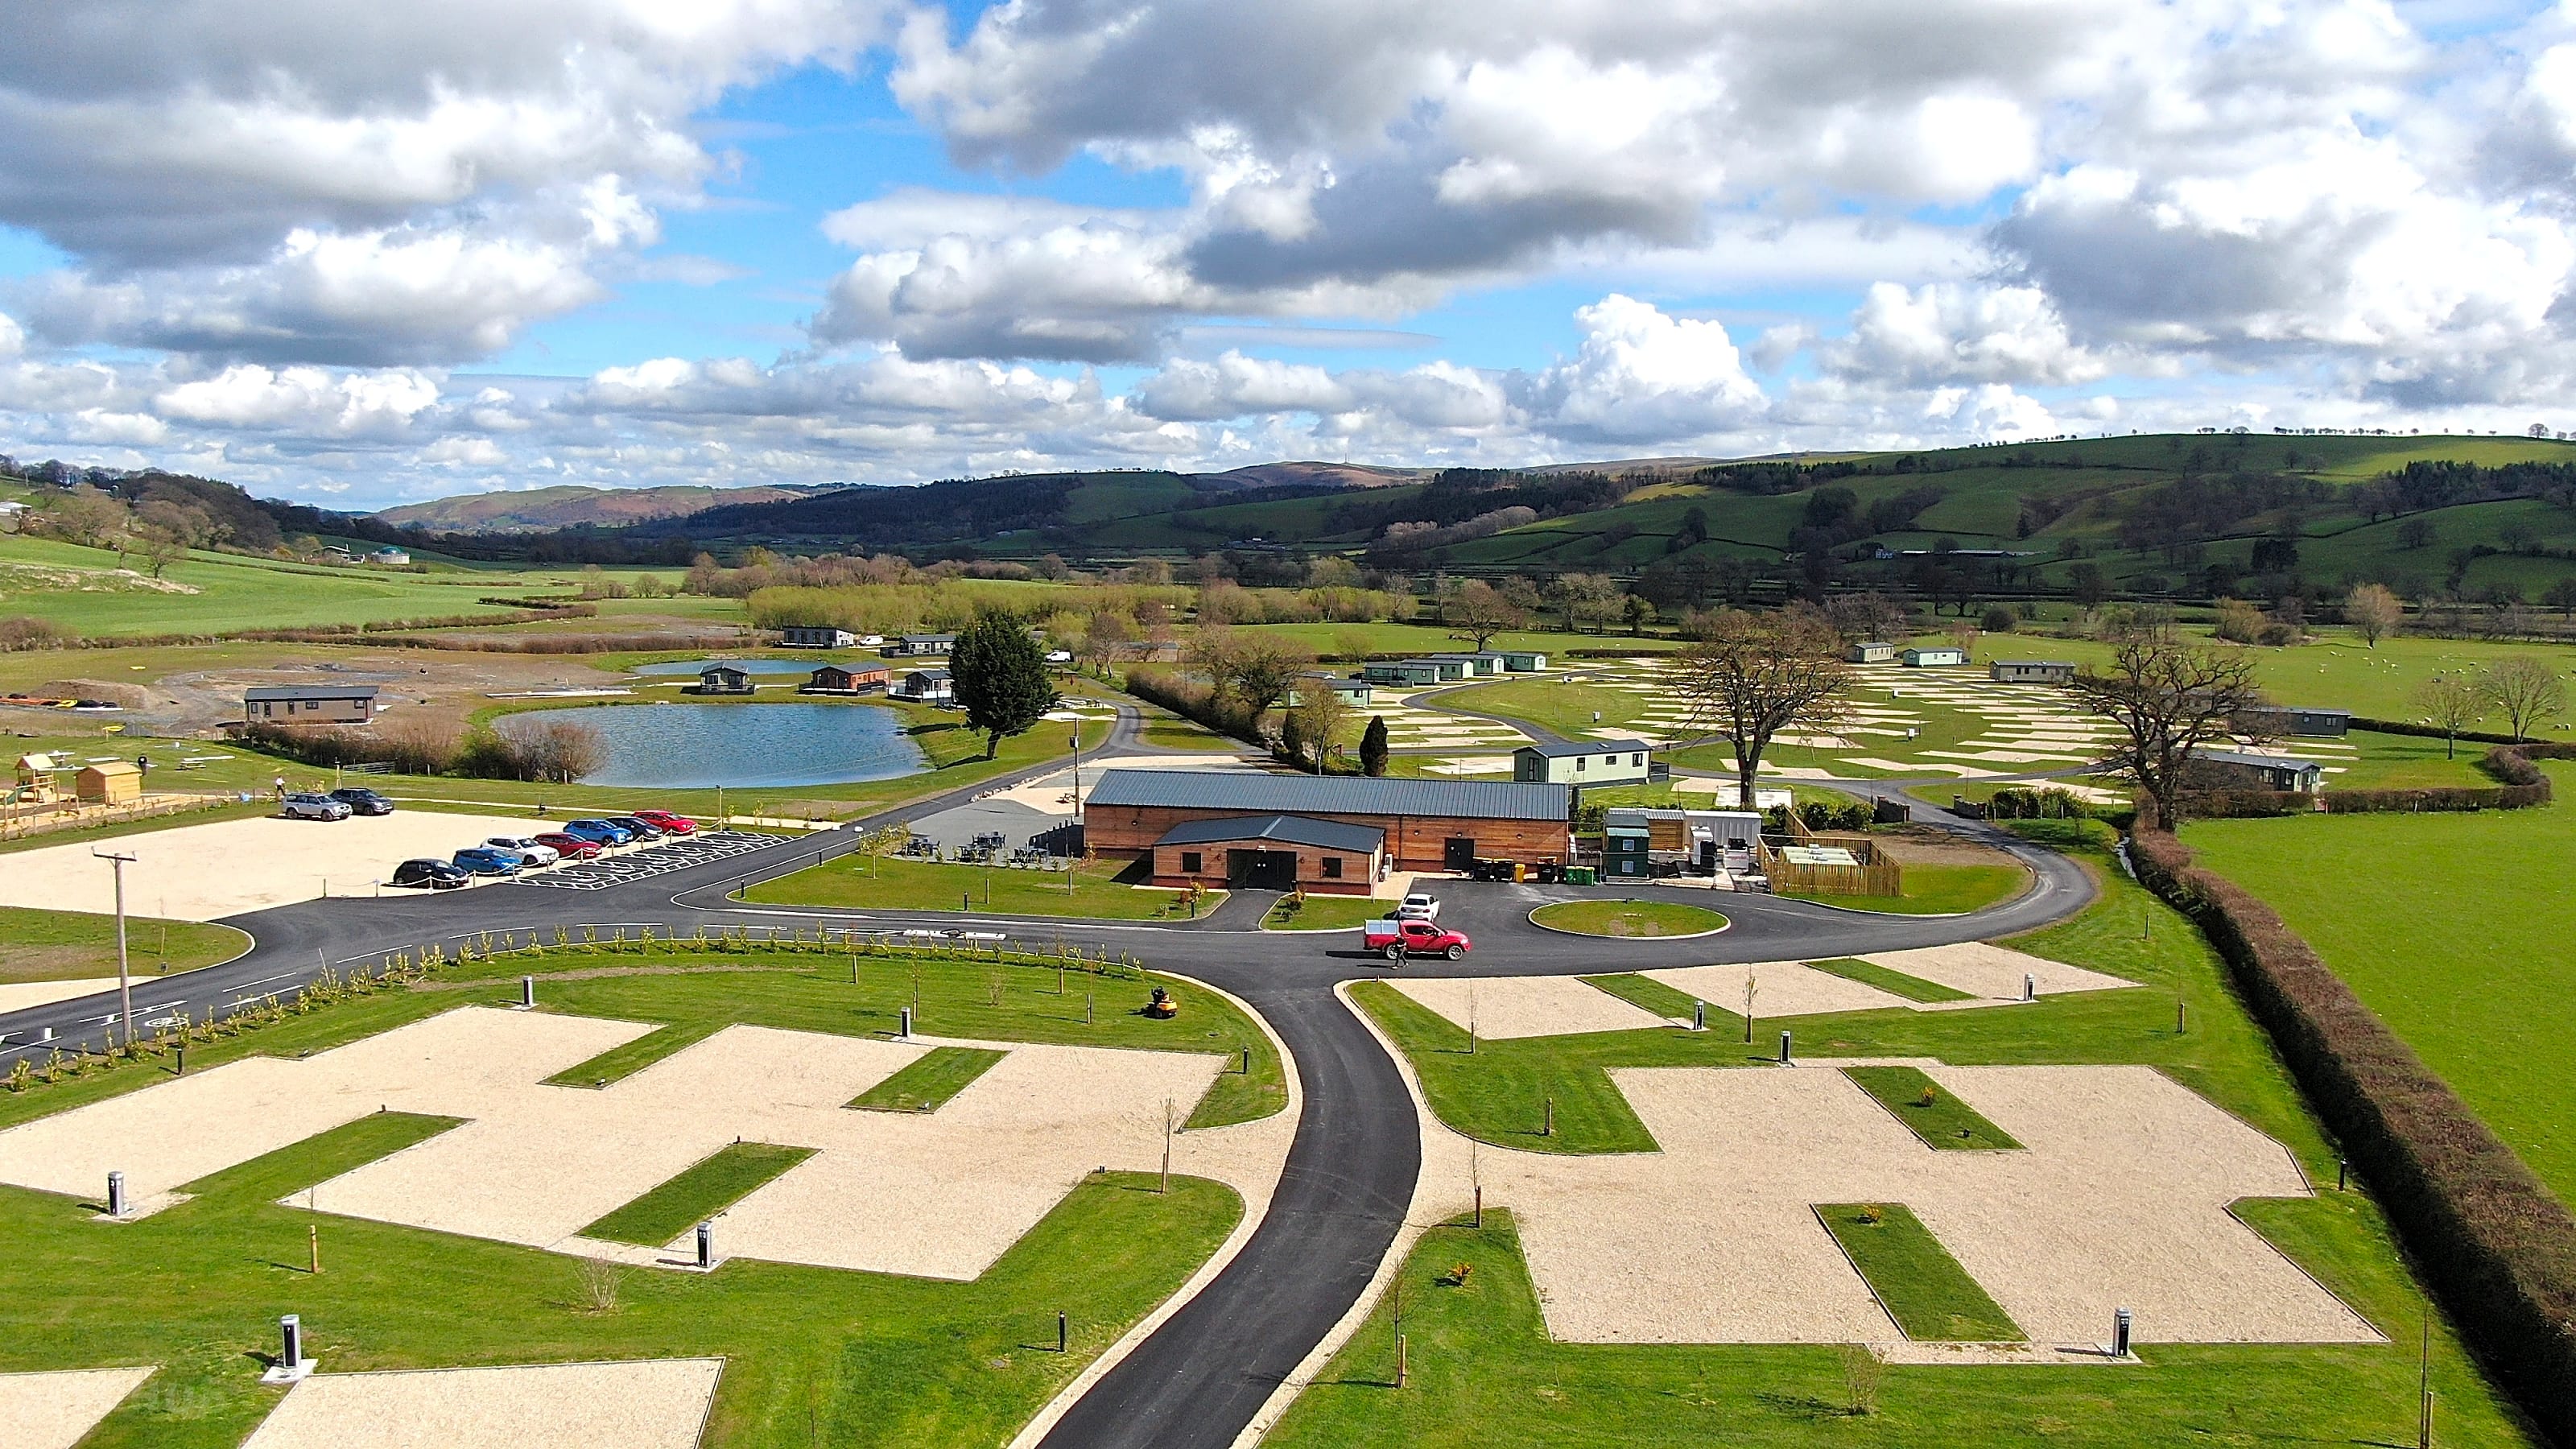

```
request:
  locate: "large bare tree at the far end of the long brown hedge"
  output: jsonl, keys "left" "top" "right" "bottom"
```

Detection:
{"left": 2069, "top": 624, "right": 2264, "bottom": 830}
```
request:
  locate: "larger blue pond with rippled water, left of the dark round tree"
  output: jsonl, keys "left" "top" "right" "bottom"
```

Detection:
{"left": 494, "top": 704, "right": 925, "bottom": 789}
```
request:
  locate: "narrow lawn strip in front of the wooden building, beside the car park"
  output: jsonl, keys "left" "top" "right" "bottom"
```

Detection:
{"left": 745, "top": 853, "right": 1224, "bottom": 920}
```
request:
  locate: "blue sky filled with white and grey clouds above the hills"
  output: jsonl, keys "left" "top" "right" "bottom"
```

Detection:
{"left": 0, "top": 0, "right": 2576, "bottom": 508}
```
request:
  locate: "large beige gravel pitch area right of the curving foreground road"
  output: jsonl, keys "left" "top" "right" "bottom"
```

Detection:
{"left": 1484, "top": 1065, "right": 2380, "bottom": 1348}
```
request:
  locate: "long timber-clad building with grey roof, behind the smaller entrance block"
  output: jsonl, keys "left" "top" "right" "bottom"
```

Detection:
{"left": 1082, "top": 768, "right": 1574, "bottom": 872}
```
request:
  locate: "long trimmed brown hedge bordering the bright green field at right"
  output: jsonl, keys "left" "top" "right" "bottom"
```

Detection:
{"left": 2130, "top": 830, "right": 2576, "bottom": 1444}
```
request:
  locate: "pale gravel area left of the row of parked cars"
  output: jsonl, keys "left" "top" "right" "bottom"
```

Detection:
{"left": 0, "top": 810, "right": 551, "bottom": 920}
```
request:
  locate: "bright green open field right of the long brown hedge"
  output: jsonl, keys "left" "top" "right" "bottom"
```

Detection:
{"left": 2182, "top": 763, "right": 2576, "bottom": 1202}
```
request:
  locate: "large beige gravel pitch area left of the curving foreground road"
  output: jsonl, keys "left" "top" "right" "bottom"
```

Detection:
{"left": 0, "top": 1005, "right": 1262, "bottom": 1279}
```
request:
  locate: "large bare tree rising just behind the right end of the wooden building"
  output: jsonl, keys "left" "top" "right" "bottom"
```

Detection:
{"left": 1666, "top": 609, "right": 1850, "bottom": 802}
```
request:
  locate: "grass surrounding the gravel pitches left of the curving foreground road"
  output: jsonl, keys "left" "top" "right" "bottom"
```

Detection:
{"left": 0, "top": 946, "right": 1257, "bottom": 1449}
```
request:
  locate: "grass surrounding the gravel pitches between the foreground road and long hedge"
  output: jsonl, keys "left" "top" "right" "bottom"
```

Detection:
{"left": 1270, "top": 828, "right": 2527, "bottom": 1449}
